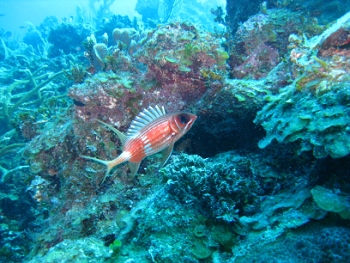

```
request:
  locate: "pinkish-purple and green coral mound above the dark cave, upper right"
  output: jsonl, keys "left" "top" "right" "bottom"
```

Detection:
{"left": 228, "top": 9, "right": 322, "bottom": 79}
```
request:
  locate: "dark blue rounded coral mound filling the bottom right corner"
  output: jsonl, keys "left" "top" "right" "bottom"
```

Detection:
{"left": 230, "top": 224, "right": 349, "bottom": 262}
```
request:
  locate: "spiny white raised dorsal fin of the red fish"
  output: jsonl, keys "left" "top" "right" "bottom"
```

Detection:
{"left": 126, "top": 105, "right": 166, "bottom": 137}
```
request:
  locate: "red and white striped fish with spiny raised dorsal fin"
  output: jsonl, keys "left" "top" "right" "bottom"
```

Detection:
{"left": 81, "top": 106, "right": 197, "bottom": 183}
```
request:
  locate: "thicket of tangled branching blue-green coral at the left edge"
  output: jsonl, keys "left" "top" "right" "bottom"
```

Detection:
{"left": 0, "top": 56, "right": 71, "bottom": 186}
